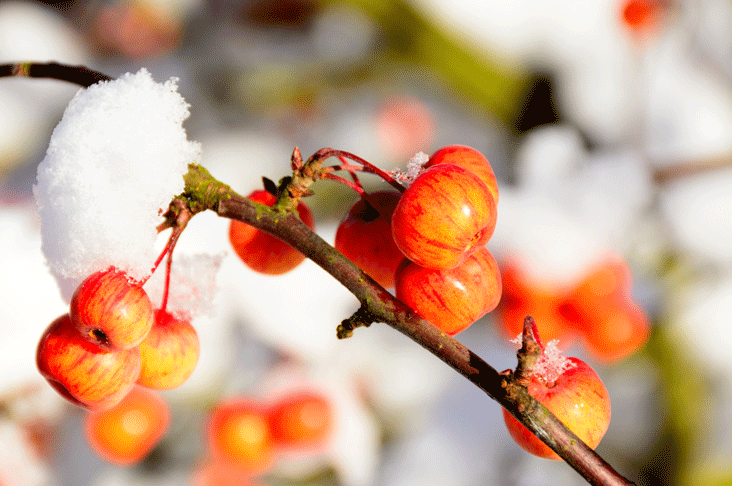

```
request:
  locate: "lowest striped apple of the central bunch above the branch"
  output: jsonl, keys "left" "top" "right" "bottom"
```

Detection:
{"left": 395, "top": 247, "right": 501, "bottom": 336}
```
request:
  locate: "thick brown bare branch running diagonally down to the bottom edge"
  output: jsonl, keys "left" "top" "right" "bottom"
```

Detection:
{"left": 186, "top": 165, "right": 633, "bottom": 486}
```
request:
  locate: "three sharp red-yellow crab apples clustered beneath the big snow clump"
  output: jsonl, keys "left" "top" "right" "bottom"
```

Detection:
{"left": 36, "top": 267, "right": 199, "bottom": 410}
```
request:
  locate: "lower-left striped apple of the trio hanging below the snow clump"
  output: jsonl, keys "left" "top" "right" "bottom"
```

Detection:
{"left": 36, "top": 314, "right": 140, "bottom": 410}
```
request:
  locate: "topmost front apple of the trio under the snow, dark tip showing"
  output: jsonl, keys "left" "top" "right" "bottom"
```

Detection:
{"left": 69, "top": 267, "right": 153, "bottom": 350}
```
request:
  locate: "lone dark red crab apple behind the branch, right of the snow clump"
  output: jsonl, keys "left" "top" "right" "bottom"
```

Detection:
{"left": 229, "top": 190, "right": 315, "bottom": 275}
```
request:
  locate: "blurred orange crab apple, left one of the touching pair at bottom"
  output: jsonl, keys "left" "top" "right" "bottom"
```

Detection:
{"left": 208, "top": 398, "right": 275, "bottom": 475}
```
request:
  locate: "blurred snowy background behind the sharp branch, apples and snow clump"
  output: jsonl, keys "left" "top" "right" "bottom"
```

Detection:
{"left": 0, "top": 0, "right": 732, "bottom": 486}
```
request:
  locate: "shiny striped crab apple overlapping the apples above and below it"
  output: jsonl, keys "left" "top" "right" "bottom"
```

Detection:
{"left": 391, "top": 164, "right": 497, "bottom": 270}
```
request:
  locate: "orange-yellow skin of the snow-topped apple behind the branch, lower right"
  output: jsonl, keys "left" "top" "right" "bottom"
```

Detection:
{"left": 502, "top": 358, "right": 610, "bottom": 460}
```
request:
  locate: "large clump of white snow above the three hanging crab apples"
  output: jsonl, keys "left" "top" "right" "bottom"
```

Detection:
{"left": 33, "top": 69, "right": 201, "bottom": 301}
